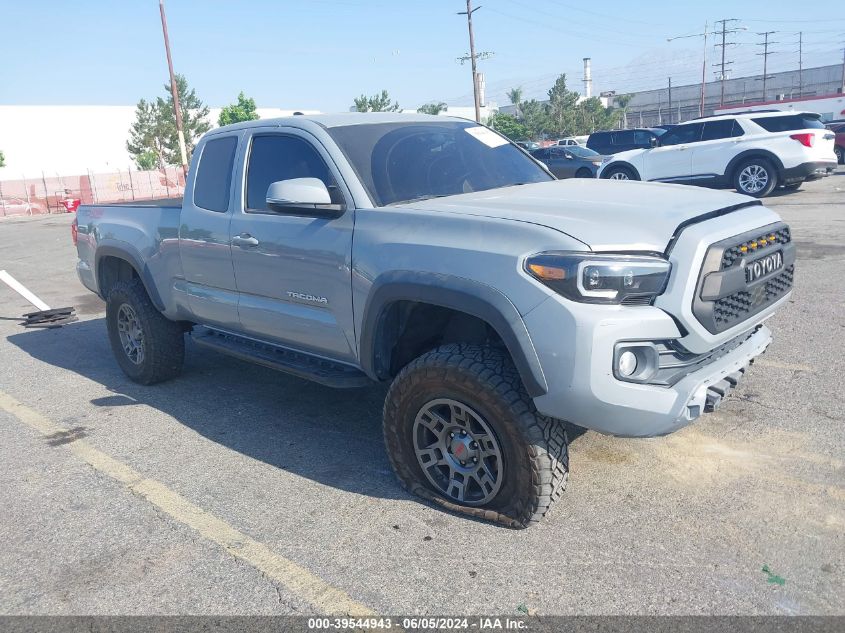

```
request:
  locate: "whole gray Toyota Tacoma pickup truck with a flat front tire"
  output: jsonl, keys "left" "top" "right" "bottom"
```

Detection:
{"left": 74, "top": 114, "right": 795, "bottom": 527}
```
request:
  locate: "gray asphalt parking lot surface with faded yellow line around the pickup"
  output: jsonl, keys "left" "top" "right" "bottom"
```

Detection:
{"left": 0, "top": 168, "right": 845, "bottom": 614}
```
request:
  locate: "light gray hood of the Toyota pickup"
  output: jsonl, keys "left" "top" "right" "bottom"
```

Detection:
{"left": 396, "top": 178, "right": 757, "bottom": 252}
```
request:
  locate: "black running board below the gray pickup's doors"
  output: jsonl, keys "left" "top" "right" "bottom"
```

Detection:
{"left": 191, "top": 327, "right": 373, "bottom": 389}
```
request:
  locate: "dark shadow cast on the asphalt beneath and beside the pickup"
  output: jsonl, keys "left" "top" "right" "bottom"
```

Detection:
{"left": 7, "top": 318, "right": 584, "bottom": 507}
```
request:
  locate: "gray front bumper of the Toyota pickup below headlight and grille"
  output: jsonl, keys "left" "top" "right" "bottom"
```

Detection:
{"left": 525, "top": 297, "right": 772, "bottom": 437}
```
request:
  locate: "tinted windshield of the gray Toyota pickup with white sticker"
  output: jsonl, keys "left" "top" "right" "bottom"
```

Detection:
{"left": 328, "top": 121, "right": 554, "bottom": 206}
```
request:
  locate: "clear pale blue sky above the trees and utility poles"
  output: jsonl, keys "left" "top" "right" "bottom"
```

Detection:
{"left": 0, "top": 0, "right": 845, "bottom": 112}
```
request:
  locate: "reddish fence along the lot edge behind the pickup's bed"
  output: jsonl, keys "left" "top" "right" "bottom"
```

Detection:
{"left": 0, "top": 167, "right": 185, "bottom": 216}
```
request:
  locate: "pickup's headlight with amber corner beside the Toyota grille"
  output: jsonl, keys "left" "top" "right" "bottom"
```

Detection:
{"left": 525, "top": 252, "right": 672, "bottom": 305}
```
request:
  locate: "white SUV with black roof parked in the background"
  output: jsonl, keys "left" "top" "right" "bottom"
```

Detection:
{"left": 598, "top": 111, "right": 836, "bottom": 198}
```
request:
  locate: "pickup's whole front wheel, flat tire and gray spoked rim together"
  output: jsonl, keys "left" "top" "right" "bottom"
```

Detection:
{"left": 384, "top": 344, "right": 569, "bottom": 528}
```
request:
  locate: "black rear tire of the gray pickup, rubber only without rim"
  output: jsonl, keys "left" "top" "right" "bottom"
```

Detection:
{"left": 106, "top": 278, "right": 185, "bottom": 385}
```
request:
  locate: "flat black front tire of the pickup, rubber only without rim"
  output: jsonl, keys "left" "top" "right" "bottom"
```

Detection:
{"left": 384, "top": 343, "right": 569, "bottom": 528}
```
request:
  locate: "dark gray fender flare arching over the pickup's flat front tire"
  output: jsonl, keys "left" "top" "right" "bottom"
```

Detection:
{"left": 359, "top": 271, "right": 548, "bottom": 398}
